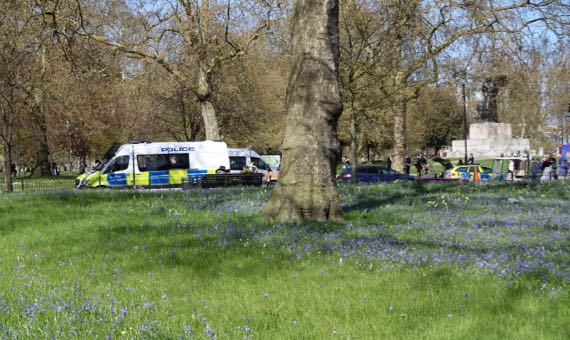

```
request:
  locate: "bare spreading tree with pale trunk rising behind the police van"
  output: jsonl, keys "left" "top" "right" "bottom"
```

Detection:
{"left": 55, "top": 0, "right": 279, "bottom": 140}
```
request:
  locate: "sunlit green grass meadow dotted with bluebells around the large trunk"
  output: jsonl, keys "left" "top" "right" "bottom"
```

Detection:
{"left": 0, "top": 182, "right": 570, "bottom": 339}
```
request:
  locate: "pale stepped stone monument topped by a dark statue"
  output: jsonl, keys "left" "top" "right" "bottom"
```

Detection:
{"left": 451, "top": 76, "right": 530, "bottom": 158}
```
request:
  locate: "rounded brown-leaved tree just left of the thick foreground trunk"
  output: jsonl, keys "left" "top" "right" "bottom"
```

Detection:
{"left": 214, "top": 44, "right": 290, "bottom": 152}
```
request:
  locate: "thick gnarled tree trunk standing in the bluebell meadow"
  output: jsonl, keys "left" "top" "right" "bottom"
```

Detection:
{"left": 264, "top": 0, "right": 342, "bottom": 221}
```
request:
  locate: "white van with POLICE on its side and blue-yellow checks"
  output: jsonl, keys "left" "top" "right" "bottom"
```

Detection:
{"left": 76, "top": 141, "right": 230, "bottom": 188}
